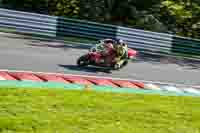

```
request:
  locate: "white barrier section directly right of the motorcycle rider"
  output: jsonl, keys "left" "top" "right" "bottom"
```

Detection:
{"left": 117, "top": 26, "right": 173, "bottom": 53}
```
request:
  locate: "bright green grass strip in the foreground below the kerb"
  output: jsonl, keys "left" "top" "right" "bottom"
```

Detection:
{"left": 0, "top": 88, "right": 200, "bottom": 133}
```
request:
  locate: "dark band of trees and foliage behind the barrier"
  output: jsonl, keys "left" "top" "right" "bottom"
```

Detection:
{"left": 1, "top": 0, "right": 200, "bottom": 38}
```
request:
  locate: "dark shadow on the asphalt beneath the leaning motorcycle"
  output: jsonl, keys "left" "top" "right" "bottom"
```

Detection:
{"left": 59, "top": 64, "right": 112, "bottom": 73}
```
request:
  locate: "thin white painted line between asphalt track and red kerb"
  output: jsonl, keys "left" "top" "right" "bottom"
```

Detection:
{"left": 0, "top": 69, "right": 197, "bottom": 87}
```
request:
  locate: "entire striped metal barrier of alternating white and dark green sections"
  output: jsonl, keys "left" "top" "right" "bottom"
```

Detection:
{"left": 0, "top": 9, "right": 200, "bottom": 58}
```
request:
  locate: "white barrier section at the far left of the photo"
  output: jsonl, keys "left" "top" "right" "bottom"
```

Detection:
{"left": 0, "top": 8, "right": 57, "bottom": 37}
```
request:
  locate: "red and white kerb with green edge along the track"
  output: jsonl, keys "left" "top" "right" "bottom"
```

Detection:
{"left": 0, "top": 70, "right": 200, "bottom": 96}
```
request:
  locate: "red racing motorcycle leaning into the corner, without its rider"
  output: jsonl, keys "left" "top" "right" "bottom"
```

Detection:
{"left": 77, "top": 40, "right": 138, "bottom": 70}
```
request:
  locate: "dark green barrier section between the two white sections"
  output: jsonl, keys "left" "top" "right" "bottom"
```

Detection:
{"left": 57, "top": 17, "right": 117, "bottom": 39}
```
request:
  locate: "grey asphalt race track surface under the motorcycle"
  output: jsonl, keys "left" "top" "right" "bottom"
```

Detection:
{"left": 0, "top": 33, "right": 200, "bottom": 85}
